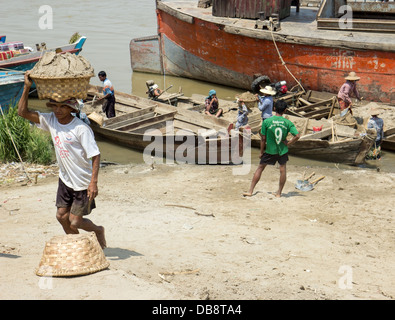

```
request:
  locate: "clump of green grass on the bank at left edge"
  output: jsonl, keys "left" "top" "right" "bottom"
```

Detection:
{"left": 0, "top": 106, "right": 55, "bottom": 165}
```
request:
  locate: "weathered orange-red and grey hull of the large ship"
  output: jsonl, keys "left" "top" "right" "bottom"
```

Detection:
{"left": 131, "top": 1, "right": 395, "bottom": 104}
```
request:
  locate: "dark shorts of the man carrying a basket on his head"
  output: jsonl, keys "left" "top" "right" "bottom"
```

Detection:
{"left": 56, "top": 179, "right": 96, "bottom": 217}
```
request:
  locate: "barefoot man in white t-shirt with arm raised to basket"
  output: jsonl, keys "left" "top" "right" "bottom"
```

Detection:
{"left": 18, "top": 71, "right": 106, "bottom": 248}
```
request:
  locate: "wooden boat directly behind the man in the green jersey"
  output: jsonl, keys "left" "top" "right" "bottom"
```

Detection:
{"left": 249, "top": 110, "right": 375, "bottom": 165}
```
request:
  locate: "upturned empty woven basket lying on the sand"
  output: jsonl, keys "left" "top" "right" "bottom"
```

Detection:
{"left": 36, "top": 232, "right": 110, "bottom": 277}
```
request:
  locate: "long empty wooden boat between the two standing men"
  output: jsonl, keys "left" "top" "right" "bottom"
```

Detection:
{"left": 85, "top": 86, "right": 249, "bottom": 164}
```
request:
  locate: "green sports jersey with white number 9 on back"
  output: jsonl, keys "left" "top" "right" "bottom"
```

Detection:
{"left": 261, "top": 116, "right": 298, "bottom": 156}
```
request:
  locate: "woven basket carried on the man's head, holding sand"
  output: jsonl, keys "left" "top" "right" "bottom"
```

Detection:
{"left": 31, "top": 74, "right": 94, "bottom": 102}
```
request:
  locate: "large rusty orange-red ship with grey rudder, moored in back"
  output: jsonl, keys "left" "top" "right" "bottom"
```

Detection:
{"left": 130, "top": 0, "right": 395, "bottom": 104}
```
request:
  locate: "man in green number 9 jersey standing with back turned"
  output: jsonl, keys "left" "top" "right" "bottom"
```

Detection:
{"left": 243, "top": 100, "right": 300, "bottom": 198}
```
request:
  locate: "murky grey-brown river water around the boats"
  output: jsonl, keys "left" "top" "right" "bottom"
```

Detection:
{"left": 0, "top": 0, "right": 395, "bottom": 172}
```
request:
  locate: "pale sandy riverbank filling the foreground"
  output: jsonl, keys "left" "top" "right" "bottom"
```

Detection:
{"left": 0, "top": 164, "right": 395, "bottom": 300}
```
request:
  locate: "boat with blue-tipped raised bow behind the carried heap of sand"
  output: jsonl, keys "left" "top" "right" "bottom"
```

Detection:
{"left": 0, "top": 37, "right": 86, "bottom": 71}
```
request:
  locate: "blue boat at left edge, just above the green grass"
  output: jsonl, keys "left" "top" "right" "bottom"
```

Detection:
{"left": 0, "top": 71, "right": 24, "bottom": 112}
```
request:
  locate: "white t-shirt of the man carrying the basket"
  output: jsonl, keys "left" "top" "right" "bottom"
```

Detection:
{"left": 37, "top": 112, "right": 100, "bottom": 191}
